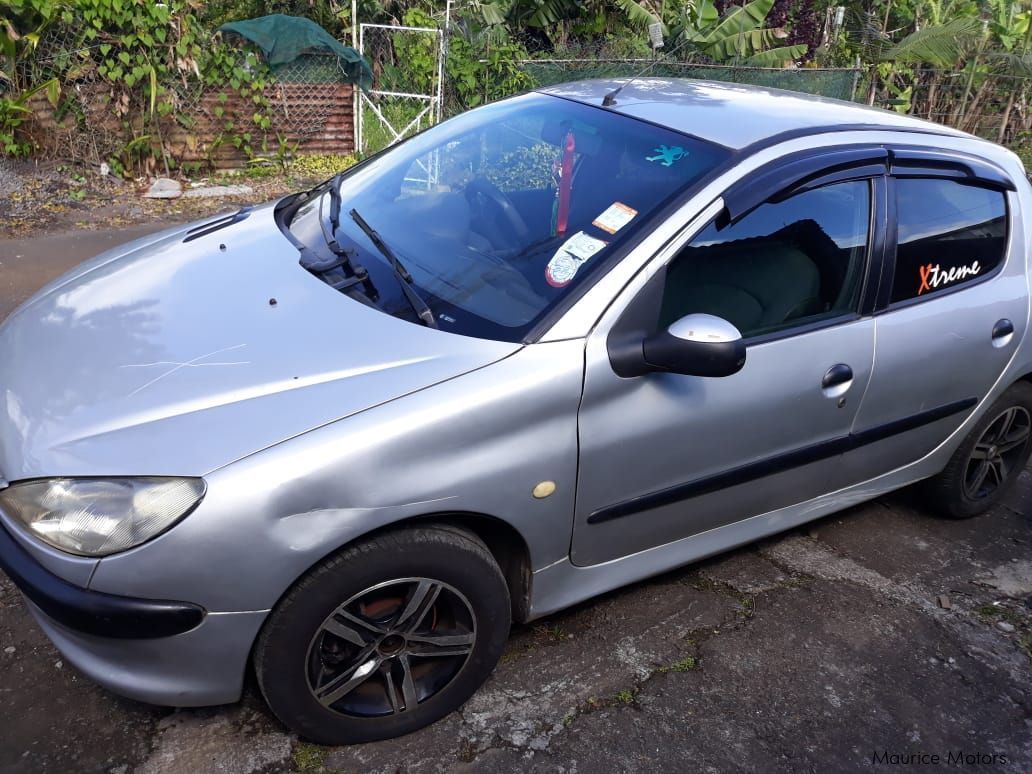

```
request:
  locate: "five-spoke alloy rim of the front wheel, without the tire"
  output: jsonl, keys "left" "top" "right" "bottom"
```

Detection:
{"left": 307, "top": 578, "right": 477, "bottom": 717}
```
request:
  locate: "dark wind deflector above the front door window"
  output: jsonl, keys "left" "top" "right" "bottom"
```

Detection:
{"left": 723, "top": 146, "right": 889, "bottom": 225}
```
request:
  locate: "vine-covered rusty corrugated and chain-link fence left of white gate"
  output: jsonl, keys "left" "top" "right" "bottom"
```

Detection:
{"left": 17, "top": 24, "right": 354, "bottom": 168}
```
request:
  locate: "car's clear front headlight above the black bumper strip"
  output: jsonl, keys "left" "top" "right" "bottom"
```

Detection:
{"left": 0, "top": 478, "right": 204, "bottom": 556}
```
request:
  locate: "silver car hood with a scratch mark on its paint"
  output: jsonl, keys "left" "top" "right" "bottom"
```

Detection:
{"left": 0, "top": 205, "right": 519, "bottom": 481}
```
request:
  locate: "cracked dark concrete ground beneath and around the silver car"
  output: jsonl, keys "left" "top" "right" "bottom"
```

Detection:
{"left": 0, "top": 227, "right": 1032, "bottom": 774}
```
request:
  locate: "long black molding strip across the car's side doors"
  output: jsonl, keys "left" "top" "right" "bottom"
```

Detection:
{"left": 587, "top": 397, "right": 978, "bottom": 524}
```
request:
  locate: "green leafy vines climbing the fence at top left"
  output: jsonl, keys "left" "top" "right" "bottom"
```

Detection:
{"left": 0, "top": 0, "right": 271, "bottom": 174}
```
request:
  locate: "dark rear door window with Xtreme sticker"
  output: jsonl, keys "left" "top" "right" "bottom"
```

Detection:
{"left": 892, "top": 179, "right": 1007, "bottom": 303}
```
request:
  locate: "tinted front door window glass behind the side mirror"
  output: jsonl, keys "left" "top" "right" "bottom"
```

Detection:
{"left": 659, "top": 181, "right": 871, "bottom": 337}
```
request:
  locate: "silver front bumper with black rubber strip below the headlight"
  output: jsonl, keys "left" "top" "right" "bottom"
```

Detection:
{"left": 0, "top": 525, "right": 268, "bottom": 707}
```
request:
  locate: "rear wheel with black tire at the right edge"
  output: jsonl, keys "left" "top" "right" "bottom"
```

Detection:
{"left": 922, "top": 382, "right": 1032, "bottom": 519}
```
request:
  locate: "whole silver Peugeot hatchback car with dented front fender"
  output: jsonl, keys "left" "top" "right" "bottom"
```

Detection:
{"left": 0, "top": 78, "right": 1032, "bottom": 743}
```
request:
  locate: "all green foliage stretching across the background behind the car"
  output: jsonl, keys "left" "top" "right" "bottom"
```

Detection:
{"left": 0, "top": 0, "right": 1032, "bottom": 171}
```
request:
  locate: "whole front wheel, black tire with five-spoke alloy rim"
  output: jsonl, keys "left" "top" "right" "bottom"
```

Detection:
{"left": 254, "top": 526, "right": 511, "bottom": 745}
